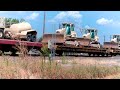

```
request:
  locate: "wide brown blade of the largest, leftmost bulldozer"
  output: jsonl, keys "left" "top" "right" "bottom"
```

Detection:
{"left": 42, "top": 34, "right": 64, "bottom": 44}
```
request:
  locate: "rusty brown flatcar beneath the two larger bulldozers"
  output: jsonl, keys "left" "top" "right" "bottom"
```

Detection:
{"left": 56, "top": 45, "right": 114, "bottom": 56}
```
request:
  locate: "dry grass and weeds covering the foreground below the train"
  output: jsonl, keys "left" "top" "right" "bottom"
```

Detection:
{"left": 0, "top": 56, "right": 120, "bottom": 79}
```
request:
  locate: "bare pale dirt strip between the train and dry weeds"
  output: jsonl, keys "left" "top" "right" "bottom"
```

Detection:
{"left": 0, "top": 56, "right": 120, "bottom": 66}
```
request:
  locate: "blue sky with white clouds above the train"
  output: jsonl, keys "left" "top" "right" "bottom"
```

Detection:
{"left": 0, "top": 11, "right": 120, "bottom": 44}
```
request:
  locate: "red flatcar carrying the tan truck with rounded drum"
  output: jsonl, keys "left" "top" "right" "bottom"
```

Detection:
{"left": 0, "top": 39, "right": 42, "bottom": 55}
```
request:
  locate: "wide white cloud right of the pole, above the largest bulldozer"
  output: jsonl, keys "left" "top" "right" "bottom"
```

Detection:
{"left": 49, "top": 11, "right": 82, "bottom": 22}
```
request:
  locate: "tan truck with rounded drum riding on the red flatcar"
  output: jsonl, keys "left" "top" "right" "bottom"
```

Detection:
{"left": 0, "top": 17, "right": 37, "bottom": 42}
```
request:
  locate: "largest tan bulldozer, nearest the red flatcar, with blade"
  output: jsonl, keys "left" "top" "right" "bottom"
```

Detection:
{"left": 41, "top": 23, "right": 77, "bottom": 45}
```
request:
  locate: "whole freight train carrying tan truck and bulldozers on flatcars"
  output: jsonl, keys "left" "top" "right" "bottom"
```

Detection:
{"left": 0, "top": 18, "right": 120, "bottom": 56}
